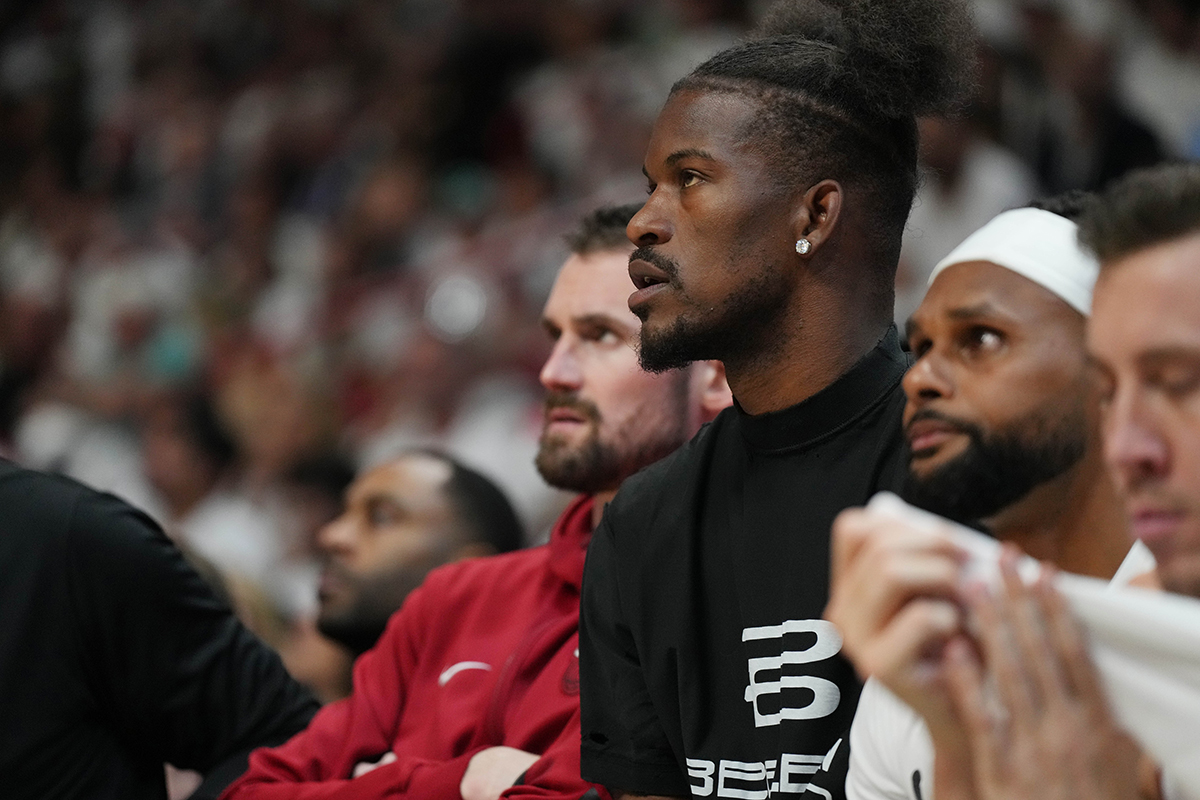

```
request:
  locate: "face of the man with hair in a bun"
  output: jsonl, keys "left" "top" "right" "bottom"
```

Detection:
{"left": 628, "top": 90, "right": 797, "bottom": 369}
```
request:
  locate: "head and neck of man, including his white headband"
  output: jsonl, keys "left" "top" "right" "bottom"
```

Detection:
{"left": 904, "top": 200, "right": 1128, "bottom": 577}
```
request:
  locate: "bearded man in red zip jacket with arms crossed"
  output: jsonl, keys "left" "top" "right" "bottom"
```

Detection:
{"left": 222, "top": 205, "right": 731, "bottom": 800}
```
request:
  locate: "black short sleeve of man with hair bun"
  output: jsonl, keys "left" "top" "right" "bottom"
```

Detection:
{"left": 580, "top": 507, "right": 691, "bottom": 796}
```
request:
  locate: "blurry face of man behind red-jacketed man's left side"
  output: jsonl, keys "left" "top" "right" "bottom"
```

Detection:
{"left": 317, "top": 455, "right": 461, "bottom": 651}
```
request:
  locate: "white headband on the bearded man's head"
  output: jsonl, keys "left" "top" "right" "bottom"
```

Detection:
{"left": 929, "top": 209, "right": 1100, "bottom": 317}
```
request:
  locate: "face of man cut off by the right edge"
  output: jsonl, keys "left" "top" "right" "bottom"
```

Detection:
{"left": 1088, "top": 235, "right": 1200, "bottom": 596}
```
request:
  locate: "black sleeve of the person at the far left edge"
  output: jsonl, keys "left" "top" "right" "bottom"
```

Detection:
{"left": 67, "top": 492, "right": 318, "bottom": 798}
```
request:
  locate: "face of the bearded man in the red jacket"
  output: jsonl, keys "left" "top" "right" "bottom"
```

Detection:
{"left": 538, "top": 249, "right": 691, "bottom": 492}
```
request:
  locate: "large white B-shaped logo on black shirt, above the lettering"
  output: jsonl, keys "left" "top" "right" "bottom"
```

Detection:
{"left": 742, "top": 619, "right": 841, "bottom": 728}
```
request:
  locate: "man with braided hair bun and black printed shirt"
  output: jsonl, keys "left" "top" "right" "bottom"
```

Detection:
{"left": 580, "top": 0, "right": 971, "bottom": 800}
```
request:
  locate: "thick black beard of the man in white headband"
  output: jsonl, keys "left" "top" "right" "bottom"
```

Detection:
{"left": 902, "top": 411, "right": 1087, "bottom": 523}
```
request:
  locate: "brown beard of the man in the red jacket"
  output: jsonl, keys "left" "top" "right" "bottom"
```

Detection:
{"left": 535, "top": 383, "right": 688, "bottom": 494}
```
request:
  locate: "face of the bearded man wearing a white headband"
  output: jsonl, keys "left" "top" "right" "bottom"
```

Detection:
{"left": 904, "top": 261, "right": 1090, "bottom": 522}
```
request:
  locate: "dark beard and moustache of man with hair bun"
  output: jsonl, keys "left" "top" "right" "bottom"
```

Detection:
{"left": 629, "top": 247, "right": 786, "bottom": 372}
